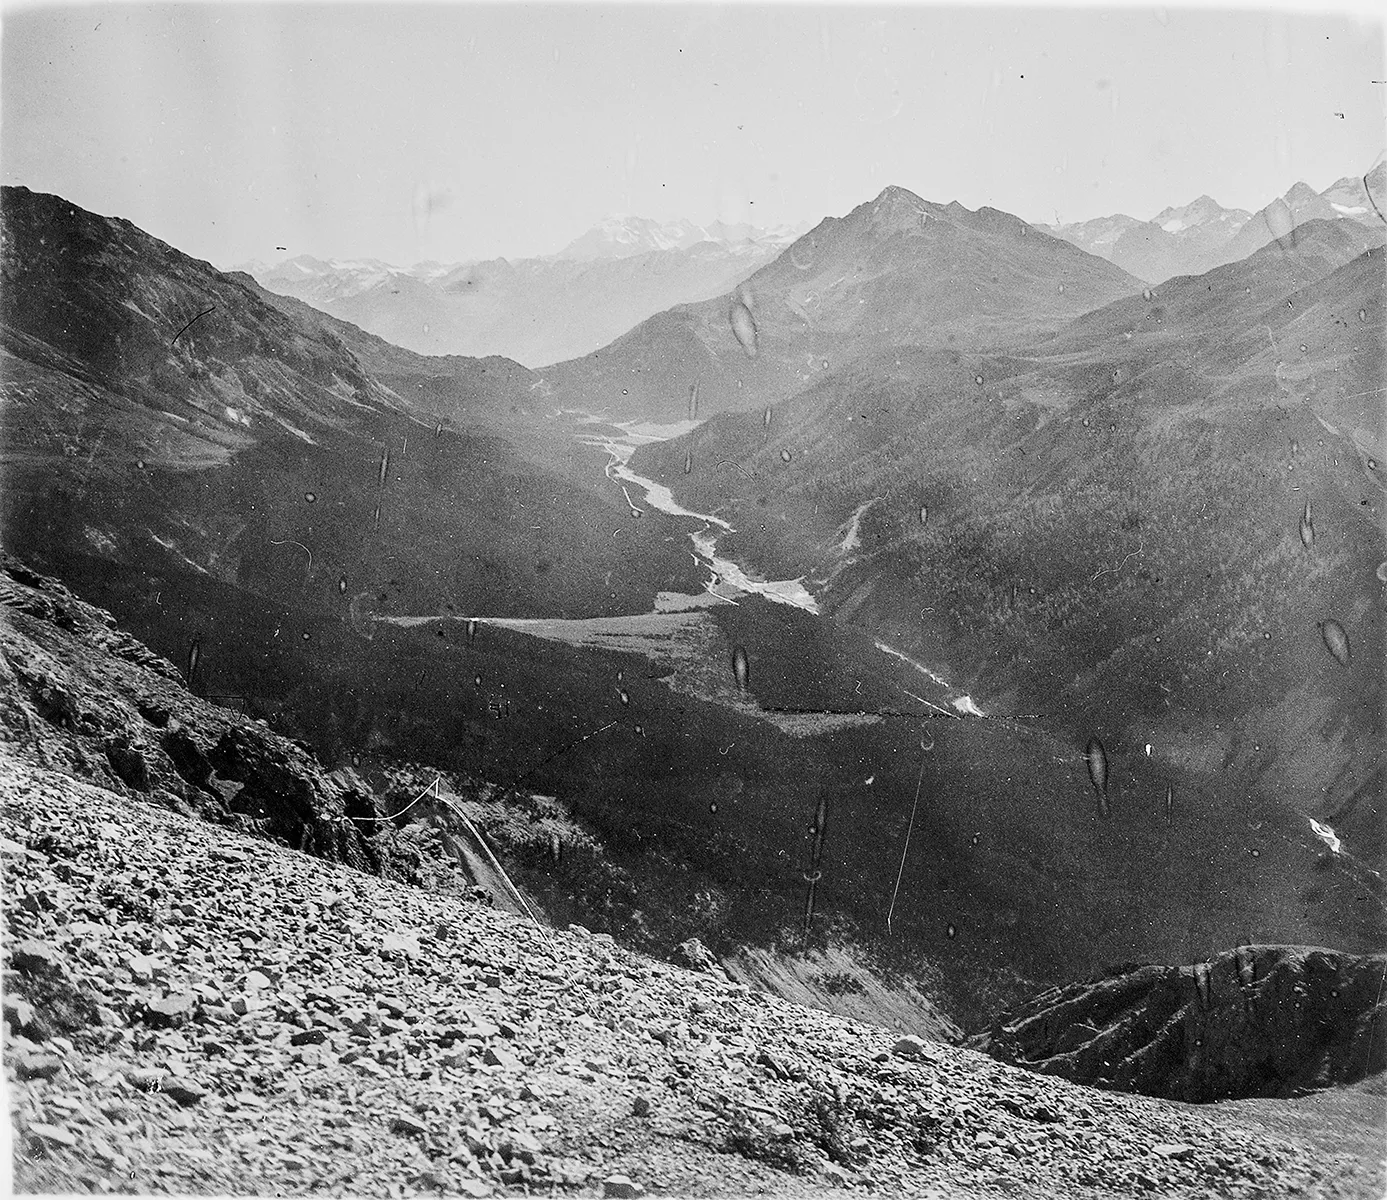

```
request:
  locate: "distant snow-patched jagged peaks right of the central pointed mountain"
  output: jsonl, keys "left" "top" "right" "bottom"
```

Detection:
{"left": 1036, "top": 160, "right": 1387, "bottom": 283}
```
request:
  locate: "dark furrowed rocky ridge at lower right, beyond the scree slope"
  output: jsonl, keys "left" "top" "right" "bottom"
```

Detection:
{"left": 972, "top": 946, "right": 1387, "bottom": 1102}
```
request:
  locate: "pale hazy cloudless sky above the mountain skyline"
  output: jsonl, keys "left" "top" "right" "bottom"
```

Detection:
{"left": 0, "top": 4, "right": 1387, "bottom": 266}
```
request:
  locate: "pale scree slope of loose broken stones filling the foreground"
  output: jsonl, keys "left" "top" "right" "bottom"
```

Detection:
{"left": 0, "top": 748, "right": 1384, "bottom": 1197}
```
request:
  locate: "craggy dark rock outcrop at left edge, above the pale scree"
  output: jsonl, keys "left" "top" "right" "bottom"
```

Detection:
{"left": 0, "top": 551, "right": 409, "bottom": 877}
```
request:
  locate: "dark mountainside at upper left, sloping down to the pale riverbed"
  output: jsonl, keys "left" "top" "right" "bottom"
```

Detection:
{"left": 0, "top": 189, "right": 704, "bottom": 668}
